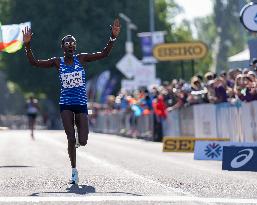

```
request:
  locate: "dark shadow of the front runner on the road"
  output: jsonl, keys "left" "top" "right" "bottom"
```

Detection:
{"left": 29, "top": 184, "right": 142, "bottom": 196}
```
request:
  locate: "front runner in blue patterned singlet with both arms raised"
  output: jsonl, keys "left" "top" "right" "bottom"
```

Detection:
{"left": 22, "top": 19, "right": 120, "bottom": 184}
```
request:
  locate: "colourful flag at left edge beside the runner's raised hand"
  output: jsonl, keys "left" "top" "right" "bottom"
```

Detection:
{"left": 0, "top": 22, "right": 31, "bottom": 53}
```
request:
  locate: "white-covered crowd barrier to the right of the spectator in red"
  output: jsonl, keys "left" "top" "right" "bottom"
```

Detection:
{"left": 163, "top": 101, "right": 257, "bottom": 142}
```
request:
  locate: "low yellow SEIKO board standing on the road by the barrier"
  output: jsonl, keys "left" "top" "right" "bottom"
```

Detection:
{"left": 163, "top": 137, "right": 229, "bottom": 152}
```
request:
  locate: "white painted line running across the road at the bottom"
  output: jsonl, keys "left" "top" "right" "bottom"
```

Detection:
{"left": 0, "top": 196, "right": 257, "bottom": 204}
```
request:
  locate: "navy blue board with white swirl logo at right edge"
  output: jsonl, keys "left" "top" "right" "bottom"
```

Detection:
{"left": 222, "top": 146, "right": 257, "bottom": 172}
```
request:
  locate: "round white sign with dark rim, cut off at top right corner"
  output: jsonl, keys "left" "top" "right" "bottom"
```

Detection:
{"left": 240, "top": 2, "right": 257, "bottom": 32}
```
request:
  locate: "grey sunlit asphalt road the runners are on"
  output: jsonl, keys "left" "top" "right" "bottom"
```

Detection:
{"left": 0, "top": 130, "right": 257, "bottom": 205}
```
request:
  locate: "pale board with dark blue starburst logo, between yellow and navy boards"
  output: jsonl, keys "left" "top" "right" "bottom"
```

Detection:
{"left": 194, "top": 141, "right": 257, "bottom": 161}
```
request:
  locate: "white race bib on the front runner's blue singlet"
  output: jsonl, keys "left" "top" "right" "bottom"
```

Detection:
{"left": 61, "top": 71, "right": 83, "bottom": 88}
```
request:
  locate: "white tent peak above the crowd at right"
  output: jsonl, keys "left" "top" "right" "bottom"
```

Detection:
{"left": 228, "top": 48, "right": 250, "bottom": 68}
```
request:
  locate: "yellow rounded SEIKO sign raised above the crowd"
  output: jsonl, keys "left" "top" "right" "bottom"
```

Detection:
{"left": 153, "top": 42, "right": 208, "bottom": 61}
